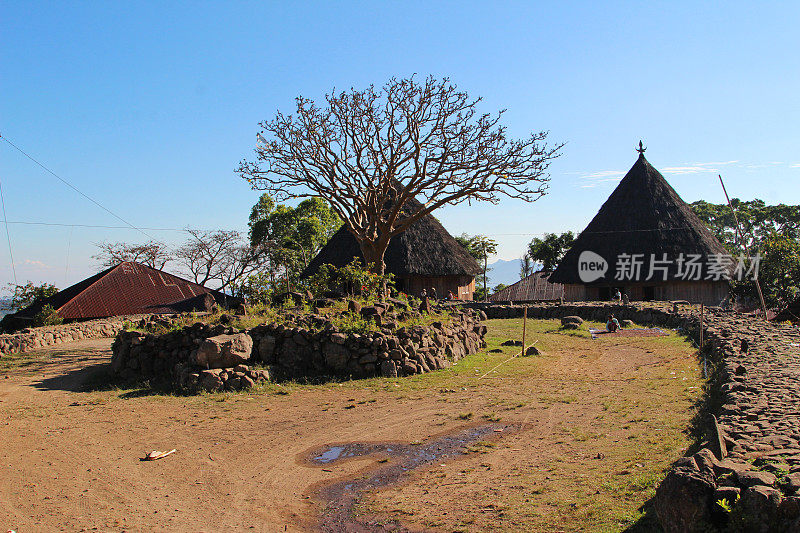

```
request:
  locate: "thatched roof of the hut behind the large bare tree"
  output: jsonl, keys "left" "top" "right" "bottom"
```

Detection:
{"left": 302, "top": 200, "right": 480, "bottom": 277}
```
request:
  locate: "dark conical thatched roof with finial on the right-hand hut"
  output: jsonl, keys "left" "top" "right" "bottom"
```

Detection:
{"left": 550, "top": 152, "right": 730, "bottom": 283}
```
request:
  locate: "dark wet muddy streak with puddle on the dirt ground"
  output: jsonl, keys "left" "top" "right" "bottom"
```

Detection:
{"left": 310, "top": 424, "right": 519, "bottom": 533}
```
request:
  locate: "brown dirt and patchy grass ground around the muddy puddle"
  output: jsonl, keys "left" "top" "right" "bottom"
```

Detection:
{"left": 0, "top": 320, "right": 700, "bottom": 533}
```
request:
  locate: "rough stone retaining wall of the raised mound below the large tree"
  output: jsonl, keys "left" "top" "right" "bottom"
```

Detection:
{"left": 112, "top": 310, "right": 486, "bottom": 389}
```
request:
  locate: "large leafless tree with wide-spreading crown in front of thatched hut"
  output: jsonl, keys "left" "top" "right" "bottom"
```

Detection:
{"left": 238, "top": 77, "right": 562, "bottom": 273}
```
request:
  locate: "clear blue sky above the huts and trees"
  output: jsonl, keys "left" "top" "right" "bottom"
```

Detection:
{"left": 0, "top": 1, "right": 800, "bottom": 287}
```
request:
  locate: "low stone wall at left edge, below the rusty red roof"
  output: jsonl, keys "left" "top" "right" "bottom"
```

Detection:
{"left": 0, "top": 317, "right": 131, "bottom": 357}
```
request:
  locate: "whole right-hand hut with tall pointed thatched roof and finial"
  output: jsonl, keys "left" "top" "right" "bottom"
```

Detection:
{"left": 550, "top": 145, "right": 732, "bottom": 305}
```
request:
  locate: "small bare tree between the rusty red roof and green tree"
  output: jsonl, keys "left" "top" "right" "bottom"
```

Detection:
{"left": 176, "top": 229, "right": 266, "bottom": 291}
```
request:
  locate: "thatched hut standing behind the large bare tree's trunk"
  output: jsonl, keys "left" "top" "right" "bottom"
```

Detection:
{"left": 301, "top": 200, "right": 481, "bottom": 300}
